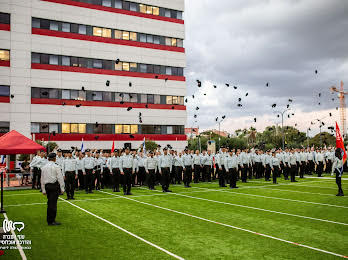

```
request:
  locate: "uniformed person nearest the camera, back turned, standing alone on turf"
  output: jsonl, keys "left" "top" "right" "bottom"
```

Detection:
{"left": 41, "top": 153, "right": 64, "bottom": 226}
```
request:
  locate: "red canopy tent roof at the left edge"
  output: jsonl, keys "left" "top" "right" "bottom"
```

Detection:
{"left": 0, "top": 130, "right": 46, "bottom": 155}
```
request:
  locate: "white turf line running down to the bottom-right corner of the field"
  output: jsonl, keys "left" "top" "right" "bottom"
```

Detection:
{"left": 99, "top": 191, "right": 348, "bottom": 258}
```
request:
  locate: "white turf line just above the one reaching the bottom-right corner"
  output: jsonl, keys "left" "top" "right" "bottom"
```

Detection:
{"left": 138, "top": 188, "right": 348, "bottom": 226}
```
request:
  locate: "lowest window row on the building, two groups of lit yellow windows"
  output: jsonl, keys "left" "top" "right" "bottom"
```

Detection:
{"left": 31, "top": 122, "right": 184, "bottom": 134}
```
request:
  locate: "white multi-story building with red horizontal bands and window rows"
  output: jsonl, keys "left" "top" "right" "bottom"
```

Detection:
{"left": 0, "top": 0, "right": 187, "bottom": 149}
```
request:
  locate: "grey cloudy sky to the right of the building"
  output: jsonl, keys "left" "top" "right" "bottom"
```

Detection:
{"left": 185, "top": 0, "right": 348, "bottom": 135}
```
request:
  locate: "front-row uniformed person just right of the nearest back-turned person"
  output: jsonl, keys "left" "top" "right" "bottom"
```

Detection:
{"left": 62, "top": 151, "right": 78, "bottom": 200}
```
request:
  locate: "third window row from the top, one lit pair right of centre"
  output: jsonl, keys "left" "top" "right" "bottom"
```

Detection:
{"left": 31, "top": 52, "right": 184, "bottom": 76}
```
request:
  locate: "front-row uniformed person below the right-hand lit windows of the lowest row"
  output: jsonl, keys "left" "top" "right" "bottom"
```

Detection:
{"left": 120, "top": 147, "right": 135, "bottom": 195}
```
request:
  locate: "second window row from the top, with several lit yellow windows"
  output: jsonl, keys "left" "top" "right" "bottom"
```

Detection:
{"left": 32, "top": 18, "right": 183, "bottom": 47}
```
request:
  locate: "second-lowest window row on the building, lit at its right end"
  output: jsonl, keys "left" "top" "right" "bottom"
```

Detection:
{"left": 31, "top": 86, "right": 184, "bottom": 105}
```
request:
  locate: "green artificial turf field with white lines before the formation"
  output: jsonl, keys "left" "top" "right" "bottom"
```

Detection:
{"left": 0, "top": 176, "right": 348, "bottom": 260}
